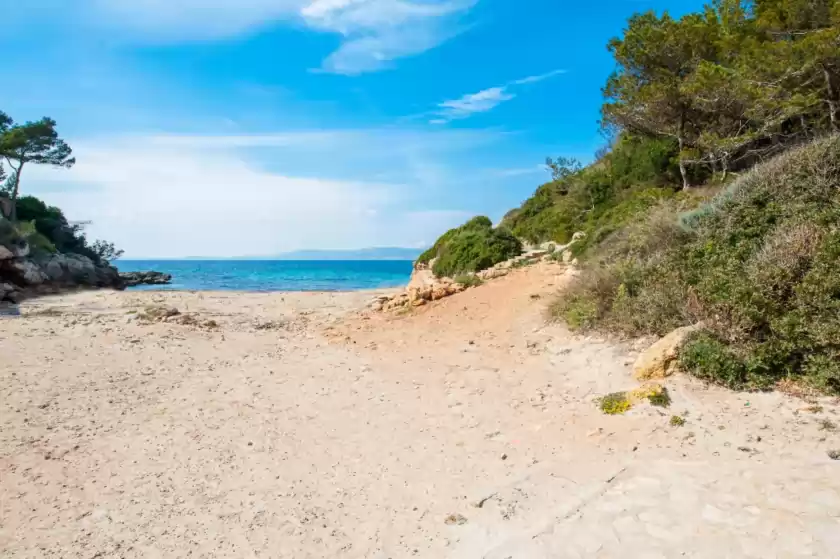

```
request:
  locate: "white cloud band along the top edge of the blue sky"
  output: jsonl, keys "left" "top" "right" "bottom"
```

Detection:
{"left": 86, "top": 0, "right": 478, "bottom": 74}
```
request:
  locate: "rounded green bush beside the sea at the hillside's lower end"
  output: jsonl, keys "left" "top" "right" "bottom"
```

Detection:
{"left": 417, "top": 216, "right": 522, "bottom": 277}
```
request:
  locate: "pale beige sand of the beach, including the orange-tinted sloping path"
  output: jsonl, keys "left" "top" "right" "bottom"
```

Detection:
{"left": 0, "top": 265, "right": 840, "bottom": 559}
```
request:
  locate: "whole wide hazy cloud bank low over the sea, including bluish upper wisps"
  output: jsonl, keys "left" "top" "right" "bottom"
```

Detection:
{"left": 26, "top": 129, "right": 498, "bottom": 257}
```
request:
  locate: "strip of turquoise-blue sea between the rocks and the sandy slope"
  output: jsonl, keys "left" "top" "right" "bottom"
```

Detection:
{"left": 120, "top": 260, "right": 412, "bottom": 291}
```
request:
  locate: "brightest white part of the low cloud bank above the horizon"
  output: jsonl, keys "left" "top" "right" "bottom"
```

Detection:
{"left": 26, "top": 135, "right": 480, "bottom": 257}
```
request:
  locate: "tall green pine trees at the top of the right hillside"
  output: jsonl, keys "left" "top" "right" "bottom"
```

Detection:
{"left": 602, "top": 0, "right": 840, "bottom": 186}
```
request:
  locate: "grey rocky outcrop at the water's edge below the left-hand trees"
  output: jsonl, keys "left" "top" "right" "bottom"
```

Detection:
{"left": 0, "top": 240, "right": 125, "bottom": 301}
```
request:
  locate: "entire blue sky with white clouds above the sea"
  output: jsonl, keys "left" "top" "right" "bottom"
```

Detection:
{"left": 0, "top": 0, "right": 700, "bottom": 258}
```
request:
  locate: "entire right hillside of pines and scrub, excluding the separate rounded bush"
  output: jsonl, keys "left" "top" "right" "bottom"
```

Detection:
{"left": 424, "top": 0, "right": 840, "bottom": 394}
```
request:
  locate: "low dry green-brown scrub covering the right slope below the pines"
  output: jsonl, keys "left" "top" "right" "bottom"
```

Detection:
{"left": 552, "top": 135, "right": 840, "bottom": 394}
